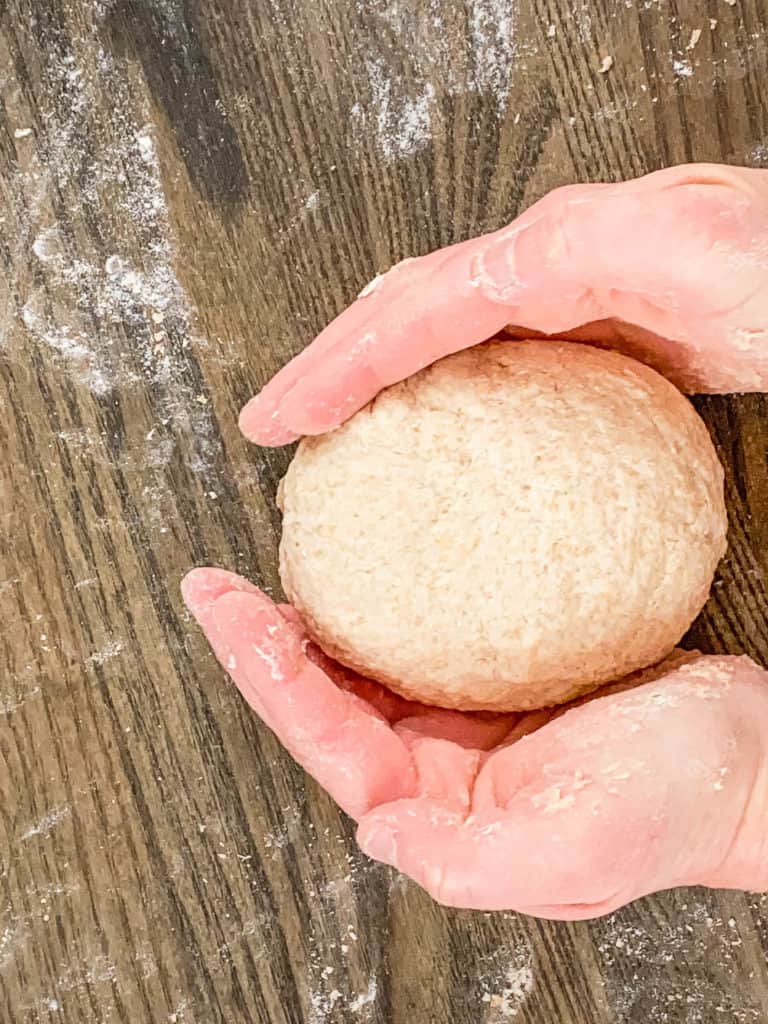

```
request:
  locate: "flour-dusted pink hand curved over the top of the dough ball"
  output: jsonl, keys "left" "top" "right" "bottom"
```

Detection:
{"left": 241, "top": 164, "right": 768, "bottom": 445}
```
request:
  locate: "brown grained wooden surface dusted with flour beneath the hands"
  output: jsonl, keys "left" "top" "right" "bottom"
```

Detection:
{"left": 0, "top": 0, "right": 768, "bottom": 1024}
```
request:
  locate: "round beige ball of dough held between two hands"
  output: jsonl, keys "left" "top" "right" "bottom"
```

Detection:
{"left": 281, "top": 341, "right": 727, "bottom": 711}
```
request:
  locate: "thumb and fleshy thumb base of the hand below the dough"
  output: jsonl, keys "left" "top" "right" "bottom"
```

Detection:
{"left": 357, "top": 657, "right": 768, "bottom": 920}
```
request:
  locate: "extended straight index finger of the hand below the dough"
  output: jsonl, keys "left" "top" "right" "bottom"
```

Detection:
{"left": 185, "top": 578, "right": 415, "bottom": 817}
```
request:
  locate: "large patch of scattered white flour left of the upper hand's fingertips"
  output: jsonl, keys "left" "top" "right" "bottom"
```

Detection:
{"left": 9, "top": 19, "right": 219, "bottom": 472}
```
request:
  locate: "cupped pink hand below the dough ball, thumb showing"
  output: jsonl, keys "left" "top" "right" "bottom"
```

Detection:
{"left": 183, "top": 569, "right": 768, "bottom": 920}
